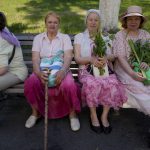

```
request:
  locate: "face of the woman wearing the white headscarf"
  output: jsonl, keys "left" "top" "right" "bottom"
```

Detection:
{"left": 86, "top": 13, "right": 100, "bottom": 32}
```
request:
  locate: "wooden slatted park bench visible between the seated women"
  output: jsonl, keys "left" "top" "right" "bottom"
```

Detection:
{"left": 5, "top": 34, "right": 78, "bottom": 94}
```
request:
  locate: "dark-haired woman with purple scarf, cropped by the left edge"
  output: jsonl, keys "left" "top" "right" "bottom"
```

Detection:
{"left": 0, "top": 12, "right": 28, "bottom": 91}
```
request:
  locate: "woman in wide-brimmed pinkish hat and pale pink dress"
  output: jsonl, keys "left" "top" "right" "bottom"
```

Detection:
{"left": 113, "top": 6, "right": 150, "bottom": 115}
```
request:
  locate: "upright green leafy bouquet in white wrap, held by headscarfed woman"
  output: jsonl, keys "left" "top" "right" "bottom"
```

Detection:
{"left": 93, "top": 32, "right": 109, "bottom": 77}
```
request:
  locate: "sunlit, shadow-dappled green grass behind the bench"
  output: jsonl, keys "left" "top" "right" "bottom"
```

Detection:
{"left": 0, "top": 0, "right": 150, "bottom": 34}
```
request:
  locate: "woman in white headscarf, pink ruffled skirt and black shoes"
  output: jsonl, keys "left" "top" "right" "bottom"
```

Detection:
{"left": 74, "top": 9, "right": 126, "bottom": 134}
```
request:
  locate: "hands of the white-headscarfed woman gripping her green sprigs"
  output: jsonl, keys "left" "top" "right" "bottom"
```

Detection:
{"left": 90, "top": 56, "right": 106, "bottom": 68}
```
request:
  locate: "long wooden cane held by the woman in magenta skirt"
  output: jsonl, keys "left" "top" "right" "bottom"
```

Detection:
{"left": 44, "top": 68, "right": 50, "bottom": 150}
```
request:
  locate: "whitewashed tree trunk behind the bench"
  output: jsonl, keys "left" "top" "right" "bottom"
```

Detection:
{"left": 99, "top": 0, "right": 121, "bottom": 31}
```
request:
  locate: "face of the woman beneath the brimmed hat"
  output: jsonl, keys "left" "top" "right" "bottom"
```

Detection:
{"left": 127, "top": 16, "right": 141, "bottom": 30}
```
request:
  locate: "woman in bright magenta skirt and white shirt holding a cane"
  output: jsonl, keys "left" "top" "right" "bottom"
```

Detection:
{"left": 25, "top": 12, "right": 80, "bottom": 131}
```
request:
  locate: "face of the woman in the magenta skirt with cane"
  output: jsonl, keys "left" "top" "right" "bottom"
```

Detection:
{"left": 45, "top": 15, "right": 59, "bottom": 33}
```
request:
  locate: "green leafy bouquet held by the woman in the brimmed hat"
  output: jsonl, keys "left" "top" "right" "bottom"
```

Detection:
{"left": 128, "top": 40, "right": 150, "bottom": 85}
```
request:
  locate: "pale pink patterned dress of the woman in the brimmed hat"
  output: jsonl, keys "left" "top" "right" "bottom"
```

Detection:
{"left": 113, "top": 29, "right": 150, "bottom": 115}
